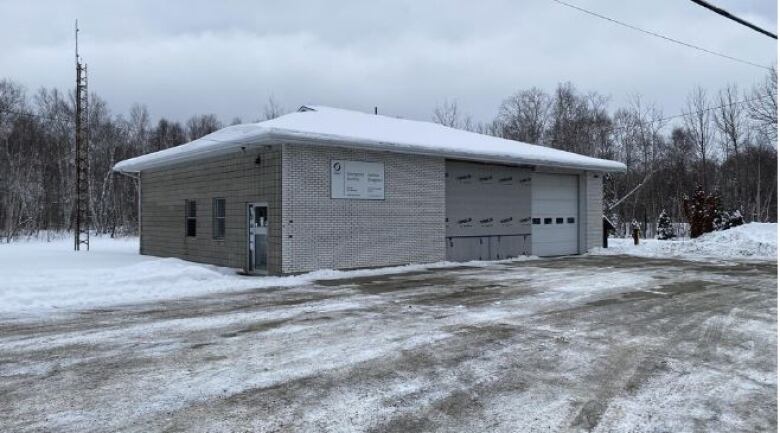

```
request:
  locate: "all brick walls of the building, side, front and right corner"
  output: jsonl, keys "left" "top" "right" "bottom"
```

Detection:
{"left": 141, "top": 144, "right": 603, "bottom": 274}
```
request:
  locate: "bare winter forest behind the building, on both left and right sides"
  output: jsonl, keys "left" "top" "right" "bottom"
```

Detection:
{"left": 0, "top": 71, "right": 777, "bottom": 240}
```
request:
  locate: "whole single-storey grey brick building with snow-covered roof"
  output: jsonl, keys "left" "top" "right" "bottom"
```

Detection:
{"left": 114, "top": 107, "right": 625, "bottom": 274}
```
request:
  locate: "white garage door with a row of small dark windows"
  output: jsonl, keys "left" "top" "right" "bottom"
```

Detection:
{"left": 531, "top": 173, "right": 579, "bottom": 256}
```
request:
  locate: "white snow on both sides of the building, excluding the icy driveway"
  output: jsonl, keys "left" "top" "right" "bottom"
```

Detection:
{"left": 0, "top": 223, "right": 777, "bottom": 317}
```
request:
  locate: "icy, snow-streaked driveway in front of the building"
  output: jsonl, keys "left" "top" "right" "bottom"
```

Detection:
{"left": 0, "top": 256, "right": 777, "bottom": 432}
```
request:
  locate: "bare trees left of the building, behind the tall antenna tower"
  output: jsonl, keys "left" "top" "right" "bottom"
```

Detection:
{"left": 0, "top": 79, "right": 283, "bottom": 241}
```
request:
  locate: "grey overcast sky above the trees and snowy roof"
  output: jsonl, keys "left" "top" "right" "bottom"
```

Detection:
{"left": 0, "top": 0, "right": 777, "bottom": 125}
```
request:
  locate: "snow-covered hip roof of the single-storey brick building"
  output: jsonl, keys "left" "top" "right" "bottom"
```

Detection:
{"left": 114, "top": 106, "right": 626, "bottom": 173}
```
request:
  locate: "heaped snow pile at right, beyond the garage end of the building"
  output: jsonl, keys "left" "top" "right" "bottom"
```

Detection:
{"left": 591, "top": 223, "right": 777, "bottom": 260}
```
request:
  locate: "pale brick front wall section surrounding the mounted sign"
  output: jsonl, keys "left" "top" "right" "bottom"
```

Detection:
{"left": 282, "top": 145, "right": 445, "bottom": 273}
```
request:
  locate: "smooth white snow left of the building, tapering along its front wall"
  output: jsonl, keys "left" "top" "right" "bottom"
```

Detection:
{"left": 0, "top": 237, "right": 532, "bottom": 317}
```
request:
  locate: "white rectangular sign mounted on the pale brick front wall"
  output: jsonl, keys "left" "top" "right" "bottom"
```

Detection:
{"left": 330, "top": 159, "right": 385, "bottom": 200}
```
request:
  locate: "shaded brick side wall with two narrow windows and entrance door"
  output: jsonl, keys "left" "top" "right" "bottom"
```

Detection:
{"left": 141, "top": 147, "right": 281, "bottom": 273}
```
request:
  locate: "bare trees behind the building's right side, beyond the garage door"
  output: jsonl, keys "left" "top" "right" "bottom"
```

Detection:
{"left": 433, "top": 69, "right": 777, "bottom": 230}
